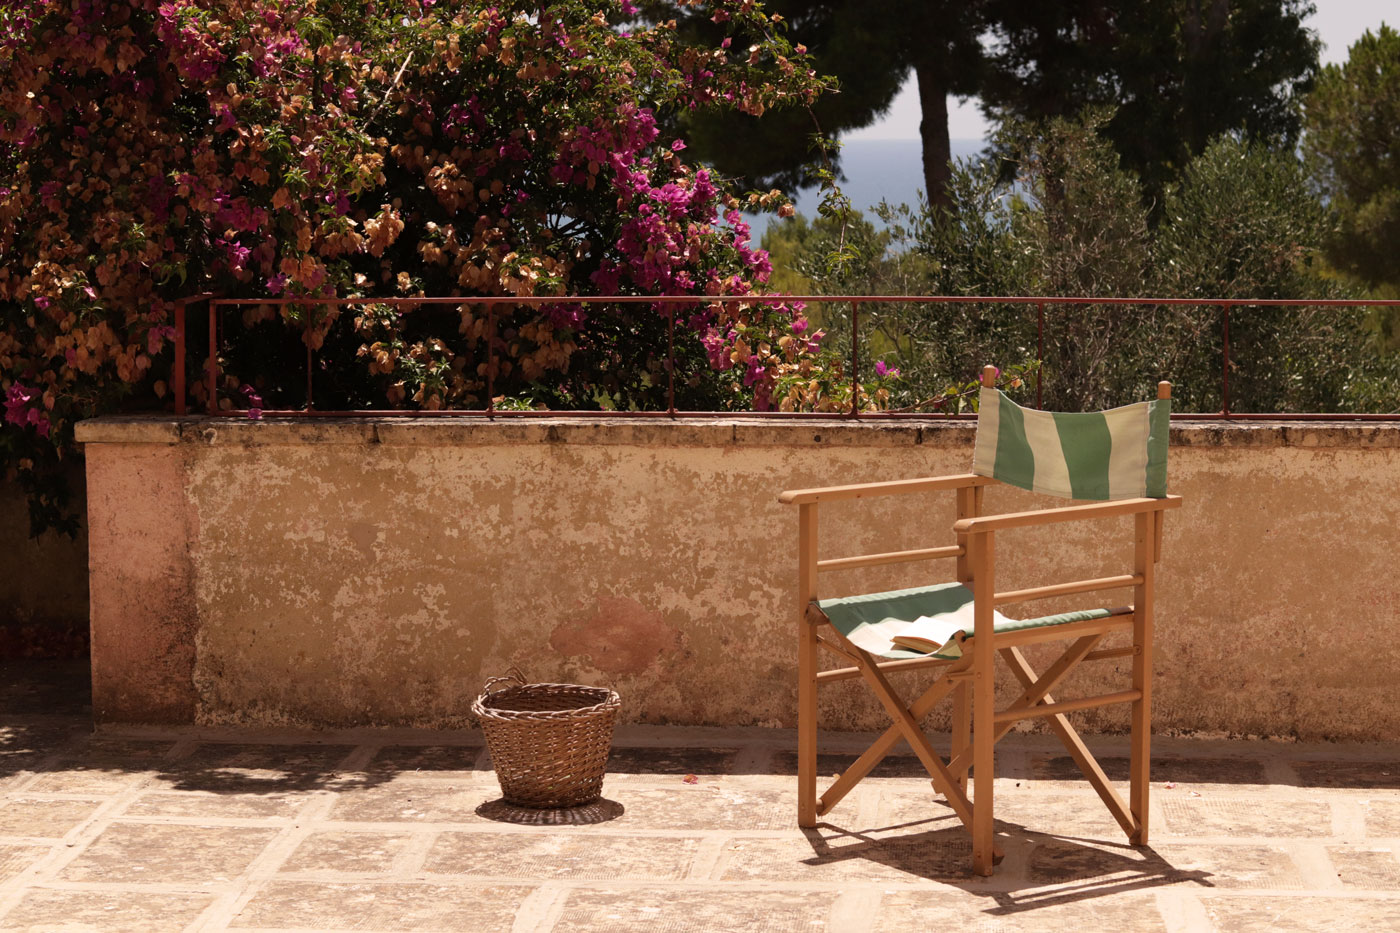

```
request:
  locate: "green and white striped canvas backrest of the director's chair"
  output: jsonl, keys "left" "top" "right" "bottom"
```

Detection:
{"left": 972, "top": 387, "right": 1172, "bottom": 499}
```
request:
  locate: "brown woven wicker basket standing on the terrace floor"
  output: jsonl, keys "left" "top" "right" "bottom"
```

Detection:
{"left": 472, "top": 668, "right": 622, "bottom": 808}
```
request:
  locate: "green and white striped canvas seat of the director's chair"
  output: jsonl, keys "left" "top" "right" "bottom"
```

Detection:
{"left": 816, "top": 583, "right": 1133, "bottom": 660}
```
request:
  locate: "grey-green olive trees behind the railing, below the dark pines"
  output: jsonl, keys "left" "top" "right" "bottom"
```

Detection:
{"left": 764, "top": 116, "right": 1400, "bottom": 412}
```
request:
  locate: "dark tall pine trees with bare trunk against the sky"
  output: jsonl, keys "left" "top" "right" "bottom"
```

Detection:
{"left": 650, "top": 0, "right": 1317, "bottom": 208}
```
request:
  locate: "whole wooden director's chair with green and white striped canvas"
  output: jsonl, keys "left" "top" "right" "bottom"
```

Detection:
{"left": 780, "top": 366, "right": 1182, "bottom": 876}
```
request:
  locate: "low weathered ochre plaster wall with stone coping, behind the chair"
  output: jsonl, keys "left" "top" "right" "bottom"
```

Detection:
{"left": 78, "top": 419, "right": 1400, "bottom": 741}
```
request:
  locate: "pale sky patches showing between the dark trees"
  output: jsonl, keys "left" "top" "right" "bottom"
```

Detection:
{"left": 843, "top": 0, "right": 1400, "bottom": 141}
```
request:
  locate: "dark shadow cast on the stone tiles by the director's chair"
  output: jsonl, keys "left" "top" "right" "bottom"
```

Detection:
{"left": 802, "top": 810, "right": 1215, "bottom": 915}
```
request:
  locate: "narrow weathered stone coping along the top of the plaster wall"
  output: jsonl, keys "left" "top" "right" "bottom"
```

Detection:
{"left": 76, "top": 415, "right": 1400, "bottom": 450}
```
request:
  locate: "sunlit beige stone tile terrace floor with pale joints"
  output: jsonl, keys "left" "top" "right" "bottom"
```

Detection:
{"left": 0, "top": 667, "right": 1400, "bottom": 933}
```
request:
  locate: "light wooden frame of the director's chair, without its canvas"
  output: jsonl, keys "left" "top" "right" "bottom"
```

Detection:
{"left": 778, "top": 373, "right": 1182, "bottom": 876}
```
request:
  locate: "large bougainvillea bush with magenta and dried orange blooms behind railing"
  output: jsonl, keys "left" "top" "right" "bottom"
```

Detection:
{"left": 0, "top": 0, "right": 823, "bottom": 524}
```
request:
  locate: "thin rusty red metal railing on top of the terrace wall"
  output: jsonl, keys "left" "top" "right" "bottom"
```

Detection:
{"left": 172, "top": 293, "right": 1400, "bottom": 420}
